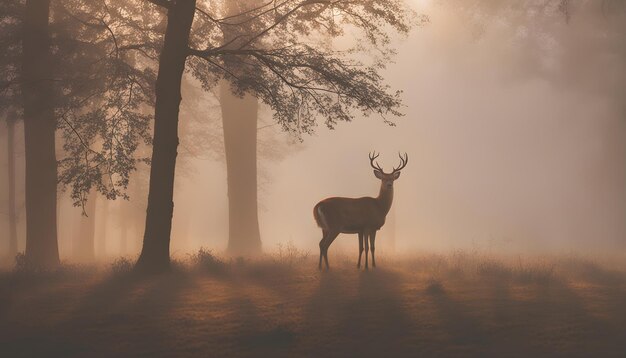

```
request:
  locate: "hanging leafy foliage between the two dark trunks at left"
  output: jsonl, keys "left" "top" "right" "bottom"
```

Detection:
{"left": 53, "top": 0, "right": 160, "bottom": 205}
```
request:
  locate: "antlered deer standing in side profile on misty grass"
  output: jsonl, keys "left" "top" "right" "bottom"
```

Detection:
{"left": 313, "top": 151, "right": 409, "bottom": 271}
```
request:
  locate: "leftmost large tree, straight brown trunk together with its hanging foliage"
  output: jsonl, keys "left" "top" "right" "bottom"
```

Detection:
{"left": 0, "top": 0, "right": 154, "bottom": 267}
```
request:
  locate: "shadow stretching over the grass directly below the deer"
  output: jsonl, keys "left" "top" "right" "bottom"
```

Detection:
{"left": 302, "top": 265, "right": 411, "bottom": 356}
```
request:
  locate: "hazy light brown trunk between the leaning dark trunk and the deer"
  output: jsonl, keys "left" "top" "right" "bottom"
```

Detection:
{"left": 220, "top": 81, "right": 261, "bottom": 255}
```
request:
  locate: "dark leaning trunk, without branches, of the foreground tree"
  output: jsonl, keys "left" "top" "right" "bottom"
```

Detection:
{"left": 136, "top": 0, "right": 196, "bottom": 272}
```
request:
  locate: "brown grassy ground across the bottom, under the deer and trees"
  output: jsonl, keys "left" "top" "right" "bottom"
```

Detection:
{"left": 0, "top": 252, "right": 626, "bottom": 357}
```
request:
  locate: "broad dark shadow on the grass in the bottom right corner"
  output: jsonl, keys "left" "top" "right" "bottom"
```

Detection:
{"left": 424, "top": 267, "right": 626, "bottom": 357}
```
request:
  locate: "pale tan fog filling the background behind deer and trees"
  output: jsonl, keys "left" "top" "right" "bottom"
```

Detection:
{"left": 0, "top": 1, "right": 626, "bottom": 258}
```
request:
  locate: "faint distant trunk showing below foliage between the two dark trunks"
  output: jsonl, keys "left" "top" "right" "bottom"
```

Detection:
{"left": 73, "top": 190, "right": 97, "bottom": 262}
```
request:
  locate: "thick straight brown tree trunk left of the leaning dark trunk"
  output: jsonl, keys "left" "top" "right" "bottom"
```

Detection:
{"left": 22, "top": 0, "right": 59, "bottom": 268}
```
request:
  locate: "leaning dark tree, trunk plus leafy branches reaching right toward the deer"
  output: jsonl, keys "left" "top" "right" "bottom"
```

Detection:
{"left": 131, "top": 0, "right": 420, "bottom": 272}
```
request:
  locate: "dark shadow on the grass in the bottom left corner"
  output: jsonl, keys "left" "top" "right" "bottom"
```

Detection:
{"left": 2, "top": 272, "right": 193, "bottom": 357}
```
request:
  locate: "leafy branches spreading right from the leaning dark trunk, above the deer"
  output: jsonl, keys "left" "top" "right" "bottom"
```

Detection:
{"left": 189, "top": 0, "right": 427, "bottom": 135}
